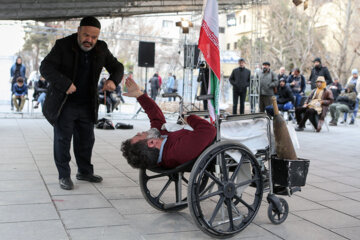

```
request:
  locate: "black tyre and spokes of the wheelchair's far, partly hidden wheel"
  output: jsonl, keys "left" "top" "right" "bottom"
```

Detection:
{"left": 139, "top": 169, "right": 188, "bottom": 212}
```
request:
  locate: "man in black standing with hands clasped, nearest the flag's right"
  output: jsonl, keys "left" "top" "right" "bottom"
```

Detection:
{"left": 229, "top": 58, "right": 251, "bottom": 114}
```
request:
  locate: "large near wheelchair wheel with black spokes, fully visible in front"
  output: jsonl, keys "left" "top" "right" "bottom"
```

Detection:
{"left": 188, "top": 141, "right": 263, "bottom": 238}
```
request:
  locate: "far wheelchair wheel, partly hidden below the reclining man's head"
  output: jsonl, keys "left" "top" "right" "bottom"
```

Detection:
{"left": 139, "top": 169, "right": 188, "bottom": 212}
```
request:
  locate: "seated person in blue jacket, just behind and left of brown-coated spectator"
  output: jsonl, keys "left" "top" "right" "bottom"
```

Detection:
{"left": 286, "top": 68, "right": 306, "bottom": 107}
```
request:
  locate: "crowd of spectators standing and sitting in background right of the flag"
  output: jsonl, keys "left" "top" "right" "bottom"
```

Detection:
{"left": 229, "top": 57, "right": 360, "bottom": 132}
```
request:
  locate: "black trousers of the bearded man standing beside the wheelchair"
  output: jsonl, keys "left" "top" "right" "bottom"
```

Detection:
{"left": 54, "top": 103, "right": 95, "bottom": 178}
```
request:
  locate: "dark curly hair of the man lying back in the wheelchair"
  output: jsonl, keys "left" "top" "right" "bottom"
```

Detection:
{"left": 121, "top": 139, "right": 160, "bottom": 168}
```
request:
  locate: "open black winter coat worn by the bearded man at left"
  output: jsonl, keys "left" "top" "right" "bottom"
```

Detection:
{"left": 40, "top": 33, "right": 124, "bottom": 125}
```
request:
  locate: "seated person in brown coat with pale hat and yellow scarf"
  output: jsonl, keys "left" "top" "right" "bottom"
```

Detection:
{"left": 295, "top": 76, "right": 334, "bottom": 132}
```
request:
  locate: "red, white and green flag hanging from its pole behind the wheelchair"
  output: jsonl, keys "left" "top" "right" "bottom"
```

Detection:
{"left": 198, "top": 0, "right": 220, "bottom": 122}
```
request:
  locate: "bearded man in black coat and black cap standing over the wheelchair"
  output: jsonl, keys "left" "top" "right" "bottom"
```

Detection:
{"left": 40, "top": 17, "right": 124, "bottom": 190}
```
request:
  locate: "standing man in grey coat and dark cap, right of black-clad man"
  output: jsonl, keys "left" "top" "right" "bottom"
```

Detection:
{"left": 259, "top": 62, "right": 279, "bottom": 112}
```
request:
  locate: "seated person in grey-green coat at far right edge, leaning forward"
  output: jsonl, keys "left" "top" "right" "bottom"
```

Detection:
{"left": 329, "top": 84, "right": 356, "bottom": 126}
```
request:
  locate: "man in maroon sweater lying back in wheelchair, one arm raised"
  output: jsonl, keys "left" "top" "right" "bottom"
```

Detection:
{"left": 121, "top": 78, "right": 216, "bottom": 168}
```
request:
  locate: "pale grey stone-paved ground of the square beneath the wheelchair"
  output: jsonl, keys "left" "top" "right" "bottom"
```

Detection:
{"left": 0, "top": 115, "right": 360, "bottom": 240}
